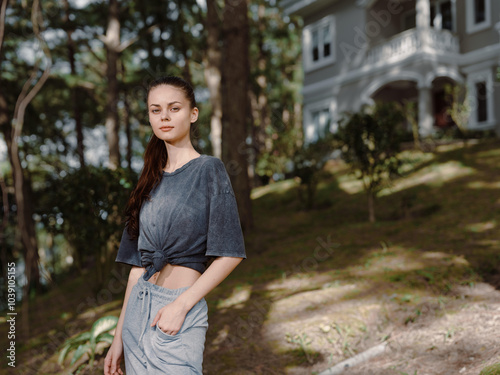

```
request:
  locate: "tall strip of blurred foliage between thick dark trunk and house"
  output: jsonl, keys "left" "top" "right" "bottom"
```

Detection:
{"left": 249, "top": 0, "right": 303, "bottom": 181}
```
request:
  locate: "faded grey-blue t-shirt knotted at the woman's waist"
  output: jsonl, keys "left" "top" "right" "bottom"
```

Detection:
{"left": 116, "top": 155, "right": 246, "bottom": 280}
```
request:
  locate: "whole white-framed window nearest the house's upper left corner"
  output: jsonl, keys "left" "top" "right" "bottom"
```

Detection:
{"left": 303, "top": 16, "right": 335, "bottom": 71}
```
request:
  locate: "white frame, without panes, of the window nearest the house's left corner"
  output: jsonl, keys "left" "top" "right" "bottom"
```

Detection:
{"left": 302, "top": 15, "right": 337, "bottom": 72}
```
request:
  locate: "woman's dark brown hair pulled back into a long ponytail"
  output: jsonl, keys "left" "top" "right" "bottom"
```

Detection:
{"left": 125, "top": 76, "right": 196, "bottom": 239}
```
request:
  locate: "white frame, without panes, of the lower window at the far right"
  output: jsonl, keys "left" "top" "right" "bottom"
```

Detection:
{"left": 467, "top": 68, "right": 496, "bottom": 130}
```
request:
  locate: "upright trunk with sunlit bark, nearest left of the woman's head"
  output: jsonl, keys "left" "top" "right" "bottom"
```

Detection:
{"left": 104, "top": 0, "right": 120, "bottom": 169}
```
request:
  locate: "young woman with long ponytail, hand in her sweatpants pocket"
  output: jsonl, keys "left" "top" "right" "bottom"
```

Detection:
{"left": 104, "top": 77, "right": 246, "bottom": 375}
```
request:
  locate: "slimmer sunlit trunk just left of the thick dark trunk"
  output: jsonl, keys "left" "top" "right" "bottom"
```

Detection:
{"left": 204, "top": 0, "right": 222, "bottom": 158}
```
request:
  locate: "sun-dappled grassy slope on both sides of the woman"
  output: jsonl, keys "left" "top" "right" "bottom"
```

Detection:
{"left": 5, "top": 140, "right": 500, "bottom": 375}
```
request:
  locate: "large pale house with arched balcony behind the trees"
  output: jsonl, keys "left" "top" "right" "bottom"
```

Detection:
{"left": 281, "top": 0, "right": 500, "bottom": 142}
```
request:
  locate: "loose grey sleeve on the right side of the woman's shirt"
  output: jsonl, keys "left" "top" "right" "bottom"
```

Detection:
{"left": 205, "top": 159, "right": 246, "bottom": 258}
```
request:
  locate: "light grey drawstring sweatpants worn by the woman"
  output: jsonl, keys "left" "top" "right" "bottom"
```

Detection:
{"left": 122, "top": 276, "right": 208, "bottom": 375}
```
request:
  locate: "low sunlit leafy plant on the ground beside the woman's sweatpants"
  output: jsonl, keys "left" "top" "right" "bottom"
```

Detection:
{"left": 58, "top": 316, "right": 118, "bottom": 368}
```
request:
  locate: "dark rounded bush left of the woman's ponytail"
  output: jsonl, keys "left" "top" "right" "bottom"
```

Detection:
{"left": 37, "top": 167, "right": 136, "bottom": 281}
